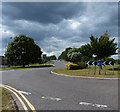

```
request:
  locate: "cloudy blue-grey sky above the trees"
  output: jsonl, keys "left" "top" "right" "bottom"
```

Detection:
{"left": 0, "top": 2, "right": 118, "bottom": 56}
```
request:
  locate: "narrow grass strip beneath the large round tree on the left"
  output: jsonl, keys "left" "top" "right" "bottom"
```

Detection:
{"left": 0, "top": 64, "right": 53, "bottom": 70}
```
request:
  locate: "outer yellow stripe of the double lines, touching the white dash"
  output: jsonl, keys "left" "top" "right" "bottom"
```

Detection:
{"left": 6, "top": 85, "right": 36, "bottom": 112}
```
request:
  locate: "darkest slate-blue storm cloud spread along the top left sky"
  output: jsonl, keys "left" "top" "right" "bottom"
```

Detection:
{"left": 3, "top": 2, "right": 85, "bottom": 24}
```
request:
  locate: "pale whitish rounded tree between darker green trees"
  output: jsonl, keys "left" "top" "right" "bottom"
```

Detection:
{"left": 67, "top": 48, "right": 82, "bottom": 63}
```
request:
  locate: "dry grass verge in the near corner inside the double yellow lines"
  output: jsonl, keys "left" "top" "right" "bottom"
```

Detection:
{"left": 0, "top": 88, "right": 18, "bottom": 112}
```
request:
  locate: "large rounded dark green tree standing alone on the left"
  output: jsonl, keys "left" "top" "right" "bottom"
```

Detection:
{"left": 5, "top": 35, "right": 42, "bottom": 67}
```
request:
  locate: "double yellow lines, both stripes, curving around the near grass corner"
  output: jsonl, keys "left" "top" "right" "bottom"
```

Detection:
{"left": 0, "top": 84, "right": 36, "bottom": 112}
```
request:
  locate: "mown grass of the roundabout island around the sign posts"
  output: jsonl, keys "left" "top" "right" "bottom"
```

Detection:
{"left": 53, "top": 66, "right": 120, "bottom": 78}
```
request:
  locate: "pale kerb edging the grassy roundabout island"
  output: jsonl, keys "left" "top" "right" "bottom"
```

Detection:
{"left": 50, "top": 71, "right": 120, "bottom": 80}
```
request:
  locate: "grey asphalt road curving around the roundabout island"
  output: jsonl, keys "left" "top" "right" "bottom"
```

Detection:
{"left": 2, "top": 61, "right": 118, "bottom": 110}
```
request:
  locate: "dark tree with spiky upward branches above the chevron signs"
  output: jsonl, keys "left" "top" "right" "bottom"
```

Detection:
{"left": 90, "top": 31, "right": 118, "bottom": 60}
